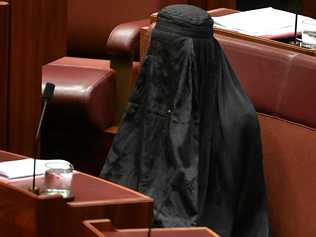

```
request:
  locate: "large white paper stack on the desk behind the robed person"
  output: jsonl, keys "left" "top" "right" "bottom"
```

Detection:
{"left": 213, "top": 7, "right": 312, "bottom": 38}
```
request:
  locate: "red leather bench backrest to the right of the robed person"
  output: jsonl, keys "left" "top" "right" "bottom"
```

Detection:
{"left": 216, "top": 35, "right": 316, "bottom": 237}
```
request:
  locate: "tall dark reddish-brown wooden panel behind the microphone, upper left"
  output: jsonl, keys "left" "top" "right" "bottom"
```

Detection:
{"left": 6, "top": 0, "right": 67, "bottom": 155}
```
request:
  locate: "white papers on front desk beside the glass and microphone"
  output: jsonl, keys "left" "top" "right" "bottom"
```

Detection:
{"left": 0, "top": 158, "right": 67, "bottom": 179}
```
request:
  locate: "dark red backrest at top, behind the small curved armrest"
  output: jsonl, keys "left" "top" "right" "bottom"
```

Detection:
{"left": 68, "top": 0, "right": 204, "bottom": 58}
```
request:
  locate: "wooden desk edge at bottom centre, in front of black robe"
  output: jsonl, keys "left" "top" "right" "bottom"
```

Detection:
{"left": 84, "top": 219, "right": 220, "bottom": 237}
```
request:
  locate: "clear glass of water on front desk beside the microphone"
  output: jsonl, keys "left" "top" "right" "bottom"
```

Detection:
{"left": 44, "top": 161, "right": 74, "bottom": 198}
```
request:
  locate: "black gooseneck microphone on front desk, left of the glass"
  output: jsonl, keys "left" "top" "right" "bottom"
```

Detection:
{"left": 31, "top": 82, "right": 55, "bottom": 194}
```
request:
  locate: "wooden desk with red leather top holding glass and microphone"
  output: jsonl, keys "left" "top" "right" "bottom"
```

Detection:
{"left": 0, "top": 151, "right": 153, "bottom": 237}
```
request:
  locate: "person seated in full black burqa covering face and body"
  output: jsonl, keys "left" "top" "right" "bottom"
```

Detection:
{"left": 101, "top": 5, "right": 269, "bottom": 237}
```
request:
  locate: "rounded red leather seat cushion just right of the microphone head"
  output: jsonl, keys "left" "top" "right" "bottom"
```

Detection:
{"left": 42, "top": 58, "right": 115, "bottom": 130}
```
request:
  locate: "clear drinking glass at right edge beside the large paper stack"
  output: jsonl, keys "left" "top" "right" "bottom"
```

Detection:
{"left": 302, "top": 19, "right": 316, "bottom": 49}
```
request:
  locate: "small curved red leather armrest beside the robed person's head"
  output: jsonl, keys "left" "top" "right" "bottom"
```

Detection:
{"left": 106, "top": 19, "right": 150, "bottom": 58}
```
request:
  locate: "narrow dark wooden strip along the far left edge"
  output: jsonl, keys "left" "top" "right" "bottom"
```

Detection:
{"left": 0, "top": 1, "right": 9, "bottom": 149}
